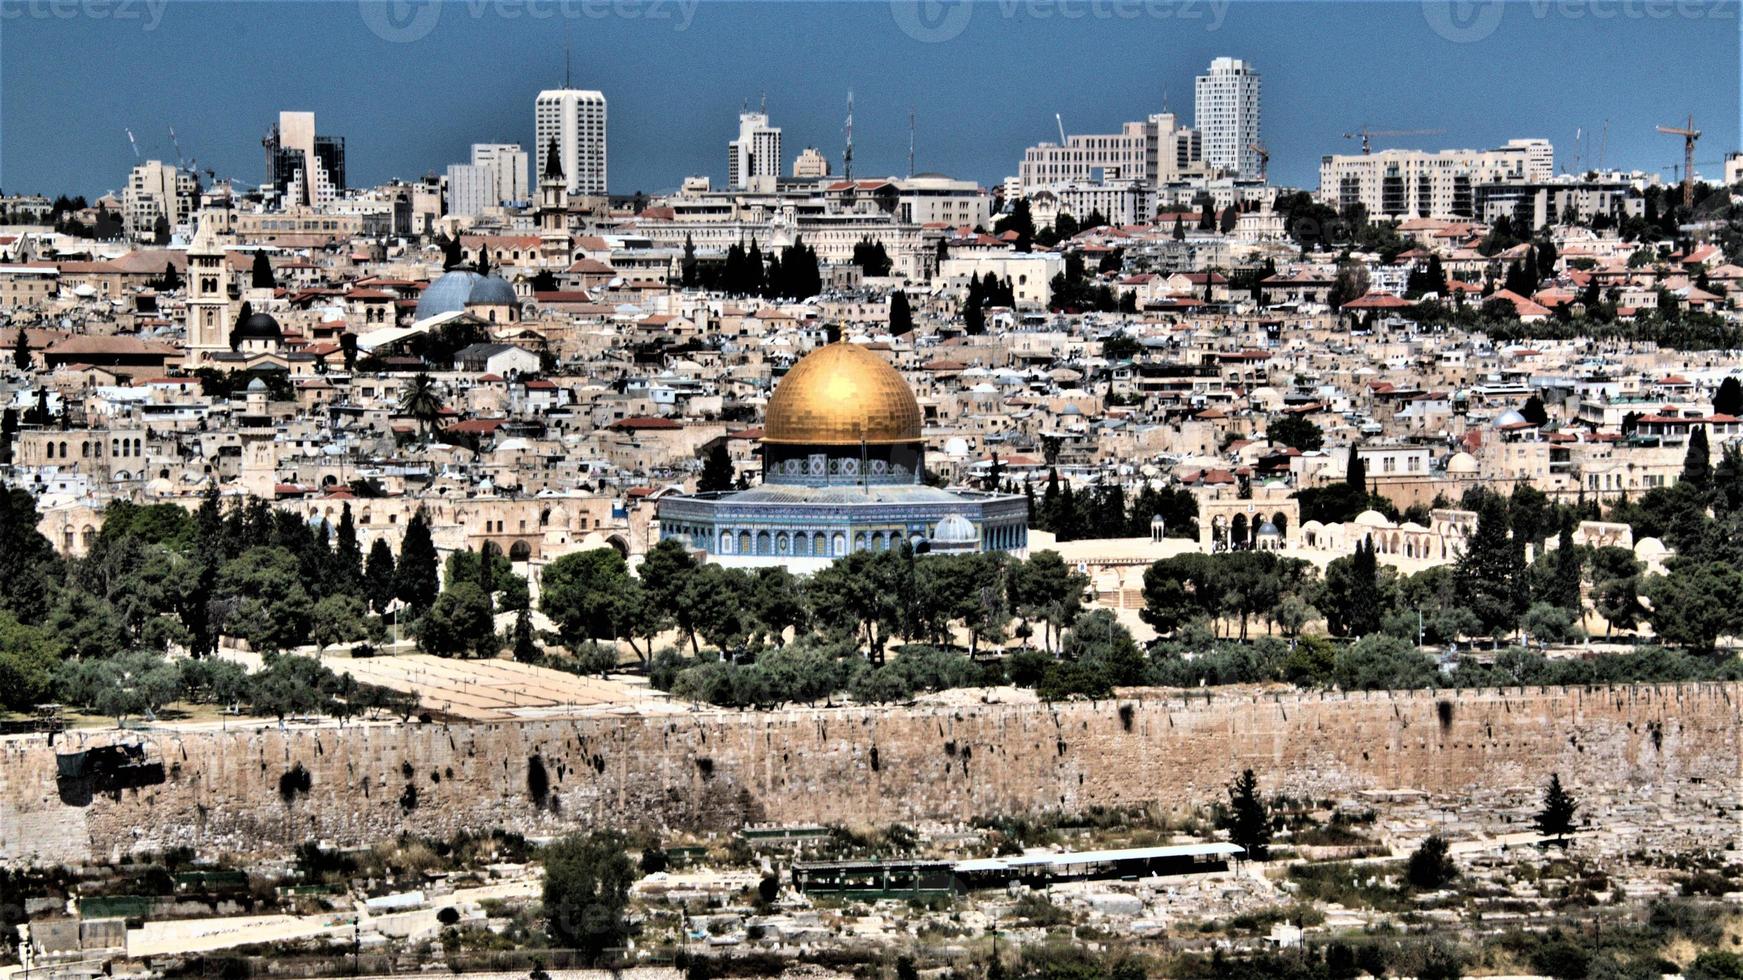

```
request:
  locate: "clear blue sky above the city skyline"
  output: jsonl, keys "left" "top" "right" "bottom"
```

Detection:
{"left": 0, "top": 0, "right": 1743, "bottom": 195}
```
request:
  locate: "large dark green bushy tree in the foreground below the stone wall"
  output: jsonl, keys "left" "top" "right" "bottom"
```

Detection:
{"left": 539, "top": 832, "right": 636, "bottom": 961}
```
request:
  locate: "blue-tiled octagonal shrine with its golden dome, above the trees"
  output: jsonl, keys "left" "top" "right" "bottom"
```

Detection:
{"left": 659, "top": 344, "right": 1028, "bottom": 570}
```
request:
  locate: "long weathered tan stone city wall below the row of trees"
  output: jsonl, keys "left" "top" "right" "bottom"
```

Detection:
{"left": 0, "top": 684, "right": 1743, "bottom": 863}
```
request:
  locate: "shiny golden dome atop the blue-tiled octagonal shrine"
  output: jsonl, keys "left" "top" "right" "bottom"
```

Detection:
{"left": 763, "top": 344, "right": 920, "bottom": 445}
